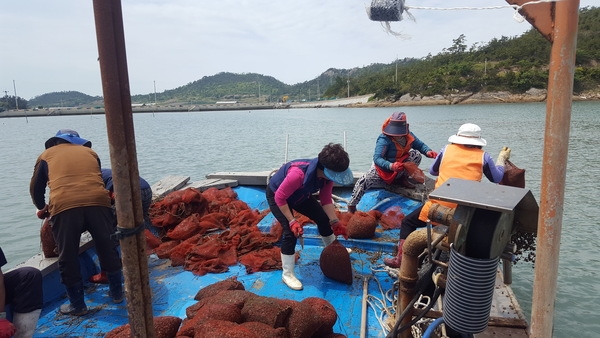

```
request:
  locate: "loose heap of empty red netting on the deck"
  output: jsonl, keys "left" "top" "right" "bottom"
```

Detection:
{"left": 146, "top": 188, "right": 281, "bottom": 276}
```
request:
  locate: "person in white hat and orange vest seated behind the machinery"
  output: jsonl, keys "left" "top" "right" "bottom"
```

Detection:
{"left": 383, "top": 123, "right": 510, "bottom": 268}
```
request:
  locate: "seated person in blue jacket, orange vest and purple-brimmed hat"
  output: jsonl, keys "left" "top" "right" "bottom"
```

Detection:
{"left": 348, "top": 112, "right": 437, "bottom": 213}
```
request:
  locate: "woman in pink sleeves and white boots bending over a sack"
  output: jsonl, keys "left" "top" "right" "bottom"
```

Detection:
{"left": 266, "top": 143, "right": 354, "bottom": 290}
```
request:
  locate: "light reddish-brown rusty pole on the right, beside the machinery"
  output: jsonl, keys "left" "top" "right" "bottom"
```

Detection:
{"left": 529, "top": 0, "right": 579, "bottom": 338}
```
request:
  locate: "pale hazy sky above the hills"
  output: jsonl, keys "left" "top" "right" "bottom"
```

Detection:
{"left": 0, "top": 0, "right": 597, "bottom": 100}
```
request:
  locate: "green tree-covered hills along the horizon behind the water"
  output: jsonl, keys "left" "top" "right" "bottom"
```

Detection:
{"left": 5, "top": 7, "right": 600, "bottom": 110}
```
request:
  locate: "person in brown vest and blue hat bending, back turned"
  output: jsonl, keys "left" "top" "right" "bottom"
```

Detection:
{"left": 29, "top": 129, "right": 123, "bottom": 316}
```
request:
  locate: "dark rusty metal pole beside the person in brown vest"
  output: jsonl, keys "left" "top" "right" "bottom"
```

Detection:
{"left": 93, "top": 0, "right": 155, "bottom": 338}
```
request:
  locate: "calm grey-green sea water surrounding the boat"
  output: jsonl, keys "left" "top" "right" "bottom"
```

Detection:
{"left": 0, "top": 102, "right": 600, "bottom": 338}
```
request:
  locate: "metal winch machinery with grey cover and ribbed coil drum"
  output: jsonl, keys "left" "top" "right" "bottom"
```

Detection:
{"left": 399, "top": 178, "right": 538, "bottom": 336}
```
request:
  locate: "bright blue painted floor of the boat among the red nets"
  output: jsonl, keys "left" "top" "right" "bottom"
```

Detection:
{"left": 30, "top": 187, "right": 420, "bottom": 337}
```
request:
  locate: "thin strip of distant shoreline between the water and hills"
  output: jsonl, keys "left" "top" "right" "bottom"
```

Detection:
{"left": 0, "top": 89, "right": 600, "bottom": 118}
